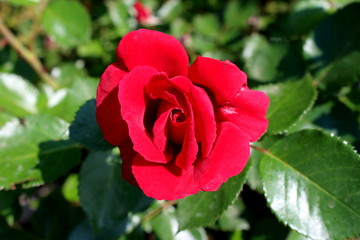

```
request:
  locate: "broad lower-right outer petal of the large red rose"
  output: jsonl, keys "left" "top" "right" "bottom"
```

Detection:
{"left": 195, "top": 122, "right": 250, "bottom": 191}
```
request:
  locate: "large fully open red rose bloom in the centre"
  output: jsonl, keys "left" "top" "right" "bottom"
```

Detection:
{"left": 96, "top": 29, "right": 269, "bottom": 200}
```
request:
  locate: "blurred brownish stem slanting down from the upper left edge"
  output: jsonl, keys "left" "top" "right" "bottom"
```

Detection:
{"left": 0, "top": 19, "right": 59, "bottom": 89}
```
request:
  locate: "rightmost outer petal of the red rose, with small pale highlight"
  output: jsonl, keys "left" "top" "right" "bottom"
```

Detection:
{"left": 216, "top": 90, "right": 270, "bottom": 142}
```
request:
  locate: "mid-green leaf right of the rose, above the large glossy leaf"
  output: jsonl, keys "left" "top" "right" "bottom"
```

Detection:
{"left": 257, "top": 76, "right": 317, "bottom": 134}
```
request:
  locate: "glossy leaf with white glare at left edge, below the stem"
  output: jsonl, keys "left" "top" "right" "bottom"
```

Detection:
{"left": 0, "top": 73, "right": 39, "bottom": 117}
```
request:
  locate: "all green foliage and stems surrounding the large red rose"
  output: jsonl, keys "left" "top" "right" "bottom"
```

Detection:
{"left": 0, "top": 0, "right": 360, "bottom": 240}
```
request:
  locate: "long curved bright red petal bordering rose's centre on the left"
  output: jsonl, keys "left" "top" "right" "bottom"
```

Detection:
{"left": 118, "top": 66, "right": 171, "bottom": 163}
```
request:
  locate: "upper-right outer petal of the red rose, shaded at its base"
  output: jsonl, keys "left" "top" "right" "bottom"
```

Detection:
{"left": 188, "top": 56, "right": 247, "bottom": 105}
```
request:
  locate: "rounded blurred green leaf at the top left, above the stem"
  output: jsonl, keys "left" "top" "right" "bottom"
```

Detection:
{"left": 41, "top": 0, "right": 91, "bottom": 47}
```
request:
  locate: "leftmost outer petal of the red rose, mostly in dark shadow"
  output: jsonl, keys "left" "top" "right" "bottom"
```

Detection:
{"left": 96, "top": 63, "right": 129, "bottom": 146}
